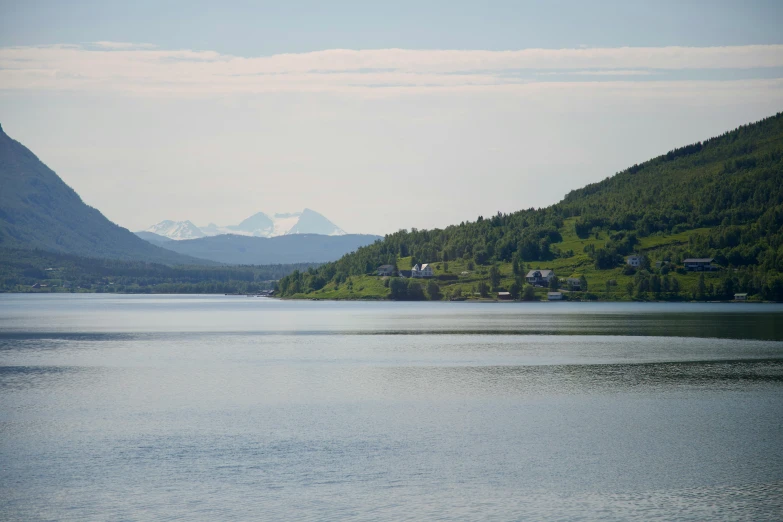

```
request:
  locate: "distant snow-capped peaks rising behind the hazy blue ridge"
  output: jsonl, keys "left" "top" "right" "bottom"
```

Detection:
{"left": 146, "top": 208, "right": 345, "bottom": 240}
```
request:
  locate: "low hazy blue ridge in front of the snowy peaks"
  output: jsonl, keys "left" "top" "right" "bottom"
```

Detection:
{"left": 152, "top": 234, "right": 380, "bottom": 265}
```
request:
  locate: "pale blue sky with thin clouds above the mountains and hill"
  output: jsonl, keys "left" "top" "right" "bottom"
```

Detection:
{"left": 0, "top": 0, "right": 783, "bottom": 234}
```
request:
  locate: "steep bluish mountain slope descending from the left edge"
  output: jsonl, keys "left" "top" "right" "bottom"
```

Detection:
{"left": 0, "top": 123, "right": 209, "bottom": 265}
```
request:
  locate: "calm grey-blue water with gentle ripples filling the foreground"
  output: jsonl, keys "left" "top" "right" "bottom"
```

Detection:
{"left": 0, "top": 295, "right": 783, "bottom": 520}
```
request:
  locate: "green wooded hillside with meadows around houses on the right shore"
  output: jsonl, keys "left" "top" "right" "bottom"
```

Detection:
{"left": 279, "top": 113, "right": 783, "bottom": 301}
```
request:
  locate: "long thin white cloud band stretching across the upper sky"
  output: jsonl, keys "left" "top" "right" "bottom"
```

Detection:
{"left": 0, "top": 42, "right": 783, "bottom": 96}
